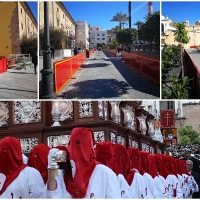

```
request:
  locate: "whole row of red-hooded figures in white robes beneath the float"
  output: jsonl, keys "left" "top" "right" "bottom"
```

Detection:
{"left": 0, "top": 127, "right": 199, "bottom": 199}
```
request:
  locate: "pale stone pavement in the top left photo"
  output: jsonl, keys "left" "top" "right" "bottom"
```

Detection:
{"left": 0, "top": 66, "right": 38, "bottom": 100}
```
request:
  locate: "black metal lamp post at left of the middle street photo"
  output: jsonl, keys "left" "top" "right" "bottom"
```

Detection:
{"left": 40, "top": 1, "right": 57, "bottom": 99}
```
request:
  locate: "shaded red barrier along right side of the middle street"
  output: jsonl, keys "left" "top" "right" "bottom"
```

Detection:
{"left": 106, "top": 49, "right": 160, "bottom": 84}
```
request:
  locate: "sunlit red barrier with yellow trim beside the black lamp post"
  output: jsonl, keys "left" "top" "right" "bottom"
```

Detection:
{"left": 54, "top": 53, "right": 86, "bottom": 94}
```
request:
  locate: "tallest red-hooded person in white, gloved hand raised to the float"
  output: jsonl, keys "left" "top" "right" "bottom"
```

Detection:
{"left": 45, "top": 127, "right": 121, "bottom": 198}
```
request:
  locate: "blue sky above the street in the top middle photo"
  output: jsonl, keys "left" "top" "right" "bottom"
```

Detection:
{"left": 62, "top": 1, "right": 160, "bottom": 31}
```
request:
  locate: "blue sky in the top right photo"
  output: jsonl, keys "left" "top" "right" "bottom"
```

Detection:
{"left": 161, "top": 1, "right": 200, "bottom": 25}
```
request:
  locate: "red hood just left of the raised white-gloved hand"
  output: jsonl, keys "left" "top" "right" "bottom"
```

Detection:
{"left": 27, "top": 144, "right": 50, "bottom": 184}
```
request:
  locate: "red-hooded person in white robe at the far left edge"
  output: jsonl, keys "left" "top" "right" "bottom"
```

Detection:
{"left": 0, "top": 137, "right": 45, "bottom": 199}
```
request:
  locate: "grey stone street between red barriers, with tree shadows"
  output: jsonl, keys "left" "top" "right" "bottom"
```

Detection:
{"left": 55, "top": 51, "right": 160, "bottom": 99}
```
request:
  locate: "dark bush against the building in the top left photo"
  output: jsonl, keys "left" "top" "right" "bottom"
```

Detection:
{"left": 20, "top": 35, "right": 38, "bottom": 56}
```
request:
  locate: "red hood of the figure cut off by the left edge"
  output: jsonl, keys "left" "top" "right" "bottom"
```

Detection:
{"left": 0, "top": 137, "right": 27, "bottom": 195}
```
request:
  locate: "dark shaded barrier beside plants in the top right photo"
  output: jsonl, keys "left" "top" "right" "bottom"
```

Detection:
{"left": 184, "top": 51, "right": 200, "bottom": 99}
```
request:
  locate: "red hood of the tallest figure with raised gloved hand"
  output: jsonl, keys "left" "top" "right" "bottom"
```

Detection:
{"left": 64, "top": 127, "right": 98, "bottom": 198}
